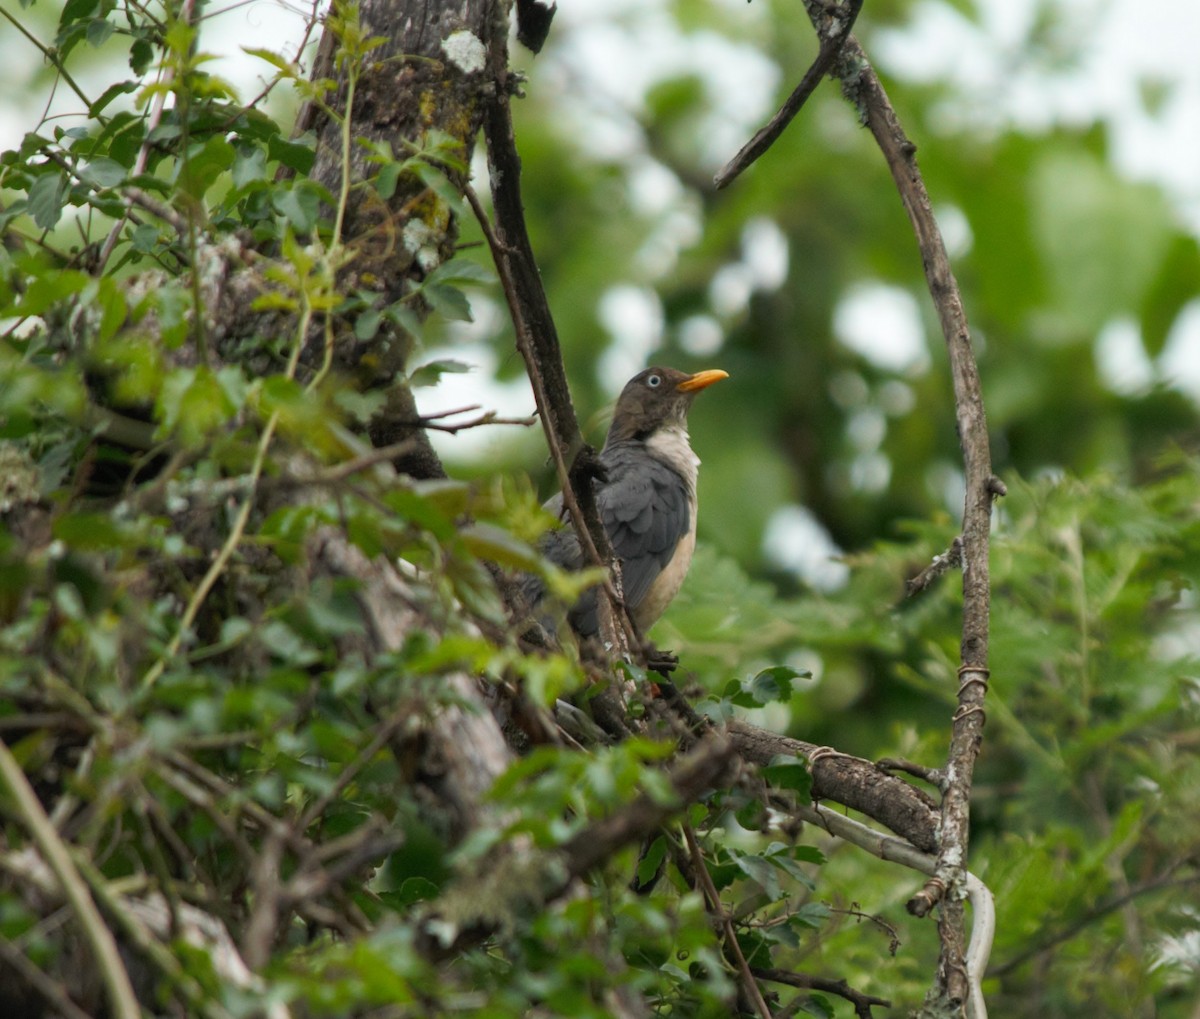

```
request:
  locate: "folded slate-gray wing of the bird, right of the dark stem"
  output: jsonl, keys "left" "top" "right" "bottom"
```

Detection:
{"left": 596, "top": 446, "right": 691, "bottom": 607}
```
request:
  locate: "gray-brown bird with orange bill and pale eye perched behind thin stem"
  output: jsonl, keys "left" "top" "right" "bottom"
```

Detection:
{"left": 522, "top": 366, "right": 728, "bottom": 637}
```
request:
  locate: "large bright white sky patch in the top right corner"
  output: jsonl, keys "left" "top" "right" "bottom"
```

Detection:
{"left": 871, "top": 0, "right": 1200, "bottom": 230}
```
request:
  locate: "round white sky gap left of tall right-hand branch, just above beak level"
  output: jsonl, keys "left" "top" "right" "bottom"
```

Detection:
{"left": 833, "top": 283, "right": 929, "bottom": 372}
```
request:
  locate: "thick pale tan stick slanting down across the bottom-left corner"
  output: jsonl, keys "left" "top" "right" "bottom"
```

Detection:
{"left": 0, "top": 743, "right": 142, "bottom": 1019}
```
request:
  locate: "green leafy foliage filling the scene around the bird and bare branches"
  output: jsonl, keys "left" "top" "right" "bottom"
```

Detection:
{"left": 0, "top": 2, "right": 1200, "bottom": 1017}
